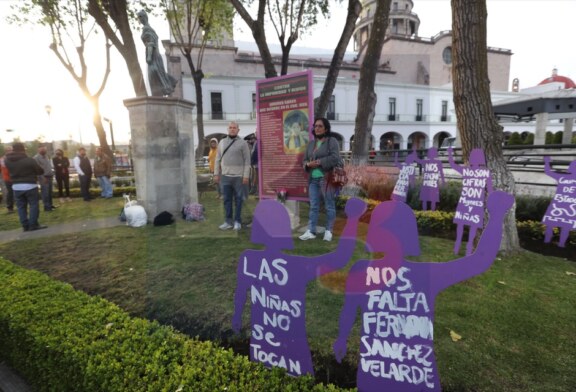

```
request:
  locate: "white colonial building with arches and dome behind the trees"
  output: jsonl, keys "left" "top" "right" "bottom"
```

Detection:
{"left": 163, "top": 0, "right": 562, "bottom": 155}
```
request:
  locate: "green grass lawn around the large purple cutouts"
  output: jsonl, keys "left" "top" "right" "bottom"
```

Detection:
{"left": 0, "top": 193, "right": 576, "bottom": 392}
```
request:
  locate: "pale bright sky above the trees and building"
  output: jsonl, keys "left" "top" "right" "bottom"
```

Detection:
{"left": 0, "top": 0, "right": 576, "bottom": 144}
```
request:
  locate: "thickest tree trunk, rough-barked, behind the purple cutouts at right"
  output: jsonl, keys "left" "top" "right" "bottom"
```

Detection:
{"left": 452, "top": 0, "right": 520, "bottom": 251}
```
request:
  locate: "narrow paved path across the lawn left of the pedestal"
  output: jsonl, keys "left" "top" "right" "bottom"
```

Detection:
{"left": 0, "top": 216, "right": 126, "bottom": 243}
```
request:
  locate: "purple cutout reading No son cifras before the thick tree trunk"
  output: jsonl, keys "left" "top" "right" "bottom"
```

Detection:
{"left": 448, "top": 147, "right": 492, "bottom": 255}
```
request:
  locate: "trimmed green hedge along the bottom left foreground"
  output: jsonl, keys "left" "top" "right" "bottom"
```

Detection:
{"left": 0, "top": 258, "right": 343, "bottom": 392}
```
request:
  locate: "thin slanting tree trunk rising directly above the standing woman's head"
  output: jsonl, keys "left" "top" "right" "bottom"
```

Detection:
{"left": 314, "top": 0, "right": 362, "bottom": 117}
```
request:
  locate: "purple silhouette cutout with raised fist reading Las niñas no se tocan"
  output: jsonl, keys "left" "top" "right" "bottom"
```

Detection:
{"left": 232, "top": 199, "right": 366, "bottom": 376}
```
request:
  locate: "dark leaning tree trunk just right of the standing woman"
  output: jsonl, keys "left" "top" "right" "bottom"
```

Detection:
{"left": 352, "top": 0, "right": 391, "bottom": 165}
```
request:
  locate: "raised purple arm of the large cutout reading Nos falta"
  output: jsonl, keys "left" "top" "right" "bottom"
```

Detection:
{"left": 430, "top": 191, "right": 514, "bottom": 292}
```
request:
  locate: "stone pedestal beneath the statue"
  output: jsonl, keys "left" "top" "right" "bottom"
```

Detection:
{"left": 124, "top": 97, "right": 198, "bottom": 221}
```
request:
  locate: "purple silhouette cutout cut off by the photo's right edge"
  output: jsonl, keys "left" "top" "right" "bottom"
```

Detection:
{"left": 542, "top": 156, "right": 576, "bottom": 248}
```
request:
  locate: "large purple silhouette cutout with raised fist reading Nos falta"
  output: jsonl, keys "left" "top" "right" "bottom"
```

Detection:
{"left": 334, "top": 192, "right": 514, "bottom": 392}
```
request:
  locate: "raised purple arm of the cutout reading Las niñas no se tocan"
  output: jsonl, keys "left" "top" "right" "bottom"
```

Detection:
{"left": 309, "top": 197, "right": 366, "bottom": 275}
